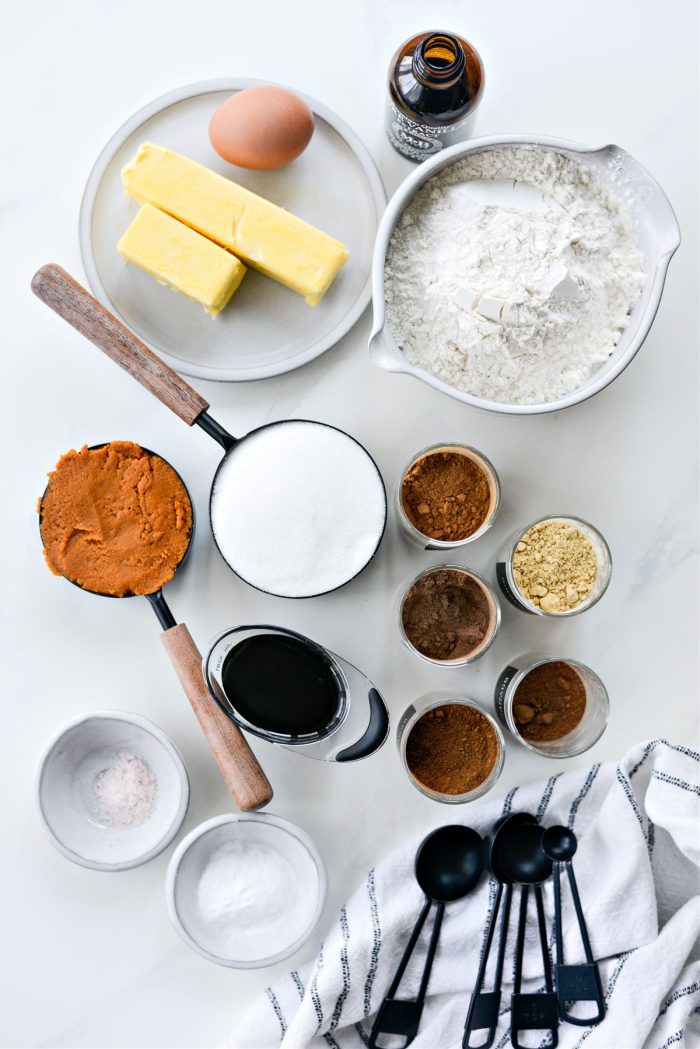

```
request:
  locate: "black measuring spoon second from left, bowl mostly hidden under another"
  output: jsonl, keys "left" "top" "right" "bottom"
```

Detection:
{"left": 462, "top": 812, "right": 535, "bottom": 1049}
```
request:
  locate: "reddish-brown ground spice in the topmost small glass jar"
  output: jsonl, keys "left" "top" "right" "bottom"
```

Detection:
{"left": 401, "top": 451, "right": 491, "bottom": 542}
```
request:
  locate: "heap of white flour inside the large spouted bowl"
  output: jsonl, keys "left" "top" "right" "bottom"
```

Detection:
{"left": 384, "top": 146, "right": 645, "bottom": 404}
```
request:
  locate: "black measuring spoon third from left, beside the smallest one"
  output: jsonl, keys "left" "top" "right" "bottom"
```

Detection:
{"left": 499, "top": 823, "right": 559, "bottom": 1049}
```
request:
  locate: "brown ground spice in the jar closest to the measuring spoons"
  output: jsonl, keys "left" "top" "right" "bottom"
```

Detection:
{"left": 406, "top": 703, "right": 500, "bottom": 794}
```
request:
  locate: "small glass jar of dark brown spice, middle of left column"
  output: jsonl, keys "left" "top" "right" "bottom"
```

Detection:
{"left": 401, "top": 566, "right": 499, "bottom": 663}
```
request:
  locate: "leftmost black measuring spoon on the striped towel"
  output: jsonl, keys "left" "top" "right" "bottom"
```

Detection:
{"left": 368, "top": 825, "right": 484, "bottom": 1049}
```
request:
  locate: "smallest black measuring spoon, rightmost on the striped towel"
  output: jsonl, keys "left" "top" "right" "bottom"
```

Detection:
{"left": 542, "top": 826, "right": 606, "bottom": 1027}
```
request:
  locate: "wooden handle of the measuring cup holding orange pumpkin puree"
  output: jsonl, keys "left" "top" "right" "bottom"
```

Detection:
{"left": 161, "top": 623, "right": 272, "bottom": 812}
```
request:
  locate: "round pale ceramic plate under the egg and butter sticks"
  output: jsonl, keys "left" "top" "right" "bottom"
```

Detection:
{"left": 80, "top": 79, "right": 386, "bottom": 382}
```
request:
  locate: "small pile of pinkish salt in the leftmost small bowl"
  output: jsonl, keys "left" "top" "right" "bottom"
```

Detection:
{"left": 92, "top": 750, "right": 157, "bottom": 828}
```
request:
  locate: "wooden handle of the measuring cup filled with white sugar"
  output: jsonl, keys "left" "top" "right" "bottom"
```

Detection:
{"left": 31, "top": 262, "right": 209, "bottom": 426}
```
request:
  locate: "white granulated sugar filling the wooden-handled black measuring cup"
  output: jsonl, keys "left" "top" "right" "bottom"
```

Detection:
{"left": 211, "top": 421, "right": 386, "bottom": 597}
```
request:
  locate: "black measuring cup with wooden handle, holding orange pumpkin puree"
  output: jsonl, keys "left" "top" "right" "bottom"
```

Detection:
{"left": 39, "top": 442, "right": 272, "bottom": 811}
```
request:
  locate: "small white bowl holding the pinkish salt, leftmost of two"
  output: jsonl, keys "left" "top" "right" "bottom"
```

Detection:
{"left": 36, "top": 710, "right": 190, "bottom": 871}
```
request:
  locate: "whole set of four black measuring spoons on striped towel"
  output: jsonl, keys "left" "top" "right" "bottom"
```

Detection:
{"left": 368, "top": 812, "right": 606, "bottom": 1049}
